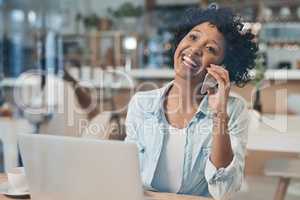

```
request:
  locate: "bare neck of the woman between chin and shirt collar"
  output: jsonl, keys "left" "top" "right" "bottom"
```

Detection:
{"left": 168, "top": 76, "right": 202, "bottom": 113}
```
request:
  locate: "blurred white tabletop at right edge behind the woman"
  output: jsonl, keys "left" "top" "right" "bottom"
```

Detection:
{"left": 247, "top": 115, "right": 300, "bottom": 153}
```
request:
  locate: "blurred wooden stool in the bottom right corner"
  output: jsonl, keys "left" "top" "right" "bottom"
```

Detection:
{"left": 264, "top": 159, "right": 300, "bottom": 200}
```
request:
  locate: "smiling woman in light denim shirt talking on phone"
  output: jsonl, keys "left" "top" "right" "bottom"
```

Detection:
{"left": 126, "top": 7, "right": 257, "bottom": 199}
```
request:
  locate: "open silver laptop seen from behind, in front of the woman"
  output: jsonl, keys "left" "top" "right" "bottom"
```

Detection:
{"left": 18, "top": 134, "right": 144, "bottom": 200}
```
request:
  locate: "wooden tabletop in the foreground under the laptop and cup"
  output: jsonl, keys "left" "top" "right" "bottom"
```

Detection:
{"left": 0, "top": 174, "right": 212, "bottom": 200}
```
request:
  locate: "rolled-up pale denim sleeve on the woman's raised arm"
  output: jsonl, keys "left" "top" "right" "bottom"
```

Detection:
{"left": 205, "top": 100, "right": 248, "bottom": 200}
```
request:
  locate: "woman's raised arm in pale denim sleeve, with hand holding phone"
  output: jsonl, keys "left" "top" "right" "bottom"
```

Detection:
{"left": 205, "top": 66, "right": 248, "bottom": 200}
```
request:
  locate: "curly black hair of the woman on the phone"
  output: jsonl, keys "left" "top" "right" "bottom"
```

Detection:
{"left": 174, "top": 6, "right": 258, "bottom": 87}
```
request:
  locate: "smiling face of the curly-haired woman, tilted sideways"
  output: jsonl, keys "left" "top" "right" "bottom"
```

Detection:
{"left": 174, "top": 22, "right": 225, "bottom": 81}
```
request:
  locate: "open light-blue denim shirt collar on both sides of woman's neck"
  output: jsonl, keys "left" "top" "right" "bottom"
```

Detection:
{"left": 153, "top": 80, "right": 211, "bottom": 117}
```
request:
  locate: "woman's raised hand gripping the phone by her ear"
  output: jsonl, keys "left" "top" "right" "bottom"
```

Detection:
{"left": 206, "top": 64, "right": 230, "bottom": 113}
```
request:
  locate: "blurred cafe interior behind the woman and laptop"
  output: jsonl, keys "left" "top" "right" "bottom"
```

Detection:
{"left": 0, "top": 0, "right": 300, "bottom": 200}
